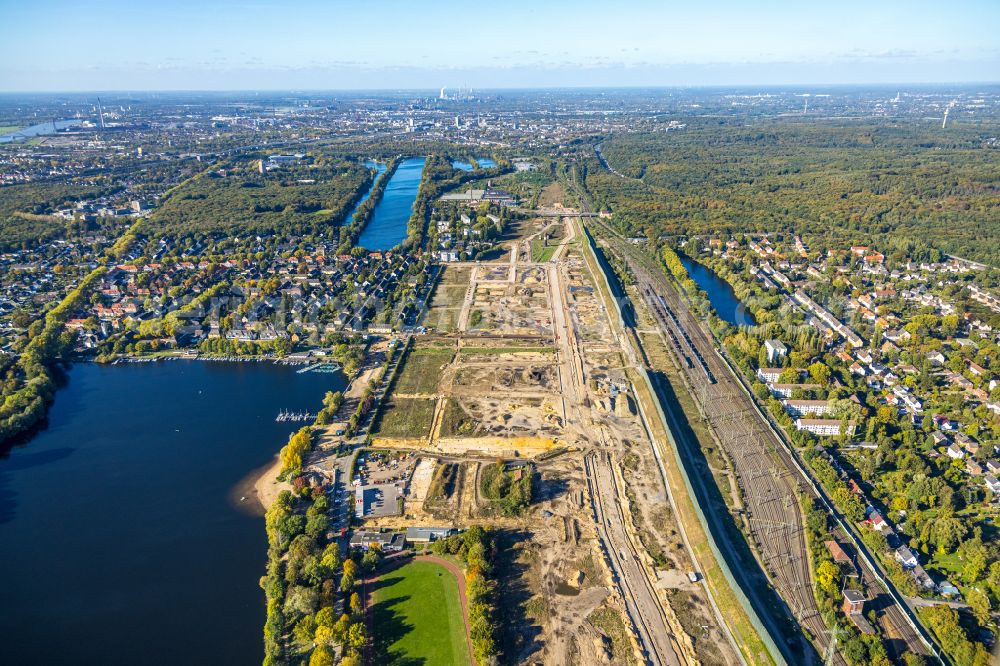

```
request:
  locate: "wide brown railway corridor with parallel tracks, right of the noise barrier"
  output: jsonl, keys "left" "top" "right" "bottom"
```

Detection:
{"left": 569, "top": 156, "right": 948, "bottom": 663}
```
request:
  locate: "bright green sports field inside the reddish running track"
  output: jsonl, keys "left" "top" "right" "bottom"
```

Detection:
{"left": 372, "top": 561, "right": 469, "bottom": 666}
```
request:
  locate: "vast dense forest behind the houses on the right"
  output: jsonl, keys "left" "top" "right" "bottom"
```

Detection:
{"left": 581, "top": 118, "right": 1000, "bottom": 266}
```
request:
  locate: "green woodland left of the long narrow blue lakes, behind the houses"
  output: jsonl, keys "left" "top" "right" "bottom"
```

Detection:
{"left": 145, "top": 157, "right": 372, "bottom": 236}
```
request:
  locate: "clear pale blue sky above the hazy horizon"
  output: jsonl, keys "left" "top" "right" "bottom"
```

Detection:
{"left": 0, "top": 0, "right": 1000, "bottom": 91}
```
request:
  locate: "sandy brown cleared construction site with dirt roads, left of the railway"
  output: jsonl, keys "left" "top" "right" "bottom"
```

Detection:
{"left": 364, "top": 211, "right": 748, "bottom": 664}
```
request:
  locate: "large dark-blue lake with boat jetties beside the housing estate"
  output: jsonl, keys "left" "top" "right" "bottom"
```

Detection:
{"left": 0, "top": 361, "right": 344, "bottom": 665}
